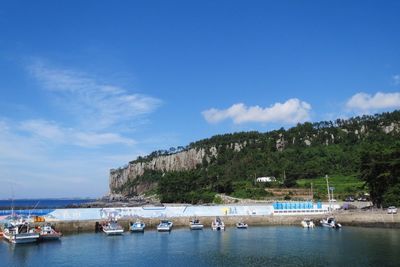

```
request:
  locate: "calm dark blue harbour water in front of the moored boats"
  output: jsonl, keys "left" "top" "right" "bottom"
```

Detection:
{"left": 0, "top": 226, "right": 400, "bottom": 267}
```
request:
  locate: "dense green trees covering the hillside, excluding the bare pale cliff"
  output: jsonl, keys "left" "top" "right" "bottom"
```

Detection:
{"left": 128, "top": 111, "right": 400, "bottom": 205}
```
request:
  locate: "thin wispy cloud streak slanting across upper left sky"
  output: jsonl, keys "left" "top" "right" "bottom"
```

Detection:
{"left": 30, "top": 62, "right": 161, "bottom": 129}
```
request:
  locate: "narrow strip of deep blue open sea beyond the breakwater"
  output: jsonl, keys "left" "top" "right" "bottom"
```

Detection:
{"left": 0, "top": 198, "right": 95, "bottom": 209}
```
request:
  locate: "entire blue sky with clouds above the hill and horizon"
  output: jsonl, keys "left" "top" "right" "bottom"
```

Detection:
{"left": 0, "top": 0, "right": 400, "bottom": 198}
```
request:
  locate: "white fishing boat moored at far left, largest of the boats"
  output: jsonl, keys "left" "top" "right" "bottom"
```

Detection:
{"left": 3, "top": 218, "right": 39, "bottom": 244}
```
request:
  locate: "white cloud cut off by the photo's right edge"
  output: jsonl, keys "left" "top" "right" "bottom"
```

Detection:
{"left": 346, "top": 92, "right": 400, "bottom": 113}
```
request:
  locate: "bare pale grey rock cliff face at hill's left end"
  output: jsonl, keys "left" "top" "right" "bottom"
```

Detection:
{"left": 109, "top": 147, "right": 217, "bottom": 194}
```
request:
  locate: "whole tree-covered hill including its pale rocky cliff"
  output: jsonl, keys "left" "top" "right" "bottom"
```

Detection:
{"left": 110, "top": 111, "right": 400, "bottom": 206}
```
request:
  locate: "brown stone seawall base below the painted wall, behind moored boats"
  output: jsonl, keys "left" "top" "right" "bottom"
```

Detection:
{"left": 53, "top": 212, "right": 400, "bottom": 234}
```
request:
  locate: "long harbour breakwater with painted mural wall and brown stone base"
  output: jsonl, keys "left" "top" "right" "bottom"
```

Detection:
{"left": 0, "top": 202, "right": 400, "bottom": 234}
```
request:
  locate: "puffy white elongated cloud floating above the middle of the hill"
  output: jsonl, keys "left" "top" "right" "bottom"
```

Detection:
{"left": 202, "top": 98, "right": 311, "bottom": 124}
